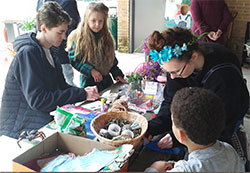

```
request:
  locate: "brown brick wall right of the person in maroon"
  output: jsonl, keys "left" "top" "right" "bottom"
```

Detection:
{"left": 225, "top": 0, "right": 250, "bottom": 61}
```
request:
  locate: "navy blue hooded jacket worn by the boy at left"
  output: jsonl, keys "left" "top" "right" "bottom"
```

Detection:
{"left": 0, "top": 33, "right": 86, "bottom": 138}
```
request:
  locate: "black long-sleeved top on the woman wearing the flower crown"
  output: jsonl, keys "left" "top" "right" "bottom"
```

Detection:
{"left": 147, "top": 43, "right": 249, "bottom": 141}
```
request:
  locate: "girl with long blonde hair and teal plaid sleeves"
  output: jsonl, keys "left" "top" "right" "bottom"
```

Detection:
{"left": 67, "top": 2, "right": 125, "bottom": 92}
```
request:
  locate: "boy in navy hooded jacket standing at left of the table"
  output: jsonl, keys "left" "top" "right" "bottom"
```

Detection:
{"left": 0, "top": 2, "right": 99, "bottom": 139}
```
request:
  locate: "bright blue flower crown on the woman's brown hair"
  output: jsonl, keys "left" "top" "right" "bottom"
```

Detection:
{"left": 149, "top": 43, "right": 188, "bottom": 65}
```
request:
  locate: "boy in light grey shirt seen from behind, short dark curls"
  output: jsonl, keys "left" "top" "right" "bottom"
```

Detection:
{"left": 145, "top": 88, "right": 245, "bottom": 172}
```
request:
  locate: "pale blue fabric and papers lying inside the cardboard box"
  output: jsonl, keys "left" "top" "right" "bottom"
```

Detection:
{"left": 24, "top": 144, "right": 134, "bottom": 172}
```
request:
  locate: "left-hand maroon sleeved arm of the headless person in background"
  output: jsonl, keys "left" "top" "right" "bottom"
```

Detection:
{"left": 190, "top": 0, "right": 211, "bottom": 33}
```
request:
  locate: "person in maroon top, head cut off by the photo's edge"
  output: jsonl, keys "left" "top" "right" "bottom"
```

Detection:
{"left": 191, "top": 0, "right": 232, "bottom": 45}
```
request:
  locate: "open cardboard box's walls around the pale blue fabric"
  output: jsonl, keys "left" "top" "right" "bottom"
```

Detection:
{"left": 12, "top": 132, "right": 115, "bottom": 172}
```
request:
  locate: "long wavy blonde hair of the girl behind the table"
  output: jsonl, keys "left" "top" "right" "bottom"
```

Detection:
{"left": 66, "top": 2, "right": 114, "bottom": 63}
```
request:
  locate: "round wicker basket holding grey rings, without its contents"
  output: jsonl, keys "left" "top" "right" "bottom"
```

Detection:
{"left": 90, "top": 112, "right": 148, "bottom": 148}
